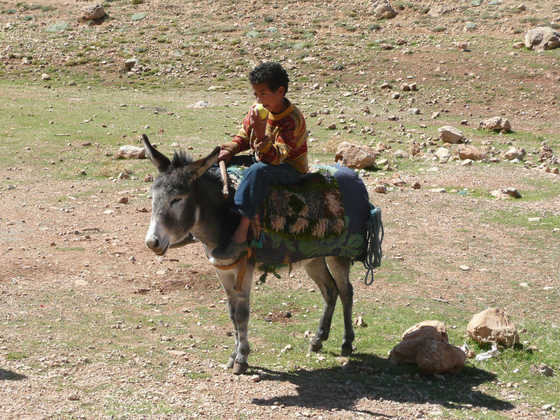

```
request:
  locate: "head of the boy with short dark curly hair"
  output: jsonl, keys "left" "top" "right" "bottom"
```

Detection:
{"left": 249, "top": 62, "right": 290, "bottom": 114}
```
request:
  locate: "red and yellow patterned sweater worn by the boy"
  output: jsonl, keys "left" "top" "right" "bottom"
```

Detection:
{"left": 222, "top": 99, "right": 309, "bottom": 173}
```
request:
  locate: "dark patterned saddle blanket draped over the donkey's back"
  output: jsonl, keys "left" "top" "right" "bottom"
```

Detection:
{"left": 228, "top": 162, "right": 369, "bottom": 265}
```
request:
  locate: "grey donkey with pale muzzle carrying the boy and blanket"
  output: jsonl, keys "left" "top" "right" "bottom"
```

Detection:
{"left": 142, "top": 135, "right": 382, "bottom": 375}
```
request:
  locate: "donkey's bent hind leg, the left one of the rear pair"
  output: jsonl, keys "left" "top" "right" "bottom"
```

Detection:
{"left": 305, "top": 258, "right": 338, "bottom": 352}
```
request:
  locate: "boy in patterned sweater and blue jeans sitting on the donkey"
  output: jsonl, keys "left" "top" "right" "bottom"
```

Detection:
{"left": 212, "top": 62, "right": 309, "bottom": 259}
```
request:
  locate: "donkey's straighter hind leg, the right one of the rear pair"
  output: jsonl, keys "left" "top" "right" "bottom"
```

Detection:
{"left": 326, "top": 257, "right": 354, "bottom": 356}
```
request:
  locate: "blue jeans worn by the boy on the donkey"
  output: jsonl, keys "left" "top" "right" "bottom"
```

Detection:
{"left": 233, "top": 162, "right": 303, "bottom": 219}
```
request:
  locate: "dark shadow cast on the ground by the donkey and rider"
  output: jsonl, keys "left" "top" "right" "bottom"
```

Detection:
{"left": 252, "top": 354, "right": 514, "bottom": 416}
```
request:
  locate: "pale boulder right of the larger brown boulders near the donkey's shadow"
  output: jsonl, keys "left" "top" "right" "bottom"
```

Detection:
{"left": 467, "top": 308, "right": 519, "bottom": 347}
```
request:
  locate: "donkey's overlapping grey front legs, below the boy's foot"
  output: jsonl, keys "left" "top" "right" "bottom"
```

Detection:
{"left": 218, "top": 262, "right": 254, "bottom": 375}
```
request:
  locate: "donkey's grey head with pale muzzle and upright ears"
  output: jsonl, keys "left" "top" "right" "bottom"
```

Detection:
{"left": 142, "top": 134, "right": 220, "bottom": 255}
